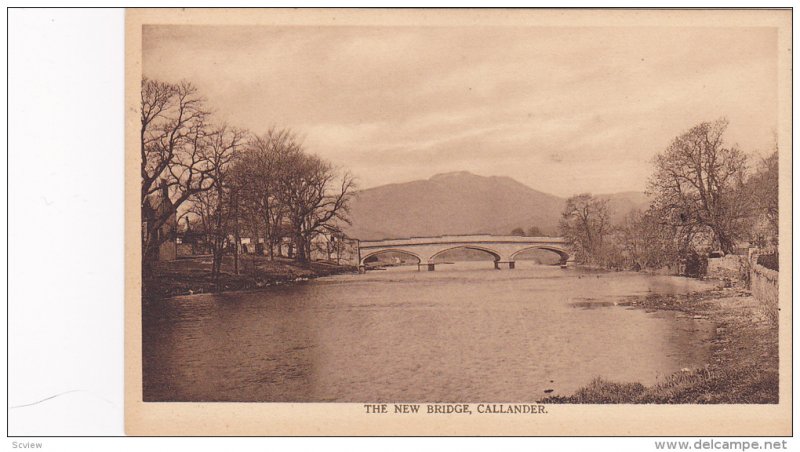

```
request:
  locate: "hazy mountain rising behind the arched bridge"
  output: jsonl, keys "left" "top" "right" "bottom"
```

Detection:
{"left": 346, "top": 171, "right": 647, "bottom": 240}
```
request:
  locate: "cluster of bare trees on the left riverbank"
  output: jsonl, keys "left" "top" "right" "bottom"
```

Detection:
{"left": 141, "top": 78, "right": 355, "bottom": 278}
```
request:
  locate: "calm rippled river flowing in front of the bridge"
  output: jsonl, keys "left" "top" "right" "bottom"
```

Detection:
{"left": 143, "top": 262, "right": 714, "bottom": 402}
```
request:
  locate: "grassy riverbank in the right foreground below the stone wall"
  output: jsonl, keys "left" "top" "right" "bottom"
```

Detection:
{"left": 541, "top": 288, "right": 778, "bottom": 403}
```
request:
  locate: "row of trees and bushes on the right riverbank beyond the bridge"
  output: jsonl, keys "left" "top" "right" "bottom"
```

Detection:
{"left": 559, "top": 118, "right": 778, "bottom": 271}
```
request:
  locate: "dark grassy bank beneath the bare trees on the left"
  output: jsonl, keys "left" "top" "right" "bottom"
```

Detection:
{"left": 142, "top": 255, "right": 358, "bottom": 299}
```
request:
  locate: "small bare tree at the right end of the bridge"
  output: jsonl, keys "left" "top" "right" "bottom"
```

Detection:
{"left": 558, "top": 193, "right": 611, "bottom": 264}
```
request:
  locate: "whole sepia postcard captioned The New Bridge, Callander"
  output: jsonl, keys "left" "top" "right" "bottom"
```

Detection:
{"left": 126, "top": 9, "right": 792, "bottom": 435}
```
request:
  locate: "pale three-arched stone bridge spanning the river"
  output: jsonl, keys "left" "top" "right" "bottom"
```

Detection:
{"left": 358, "top": 235, "right": 574, "bottom": 271}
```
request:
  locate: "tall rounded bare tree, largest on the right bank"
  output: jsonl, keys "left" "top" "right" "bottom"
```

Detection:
{"left": 648, "top": 119, "right": 750, "bottom": 253}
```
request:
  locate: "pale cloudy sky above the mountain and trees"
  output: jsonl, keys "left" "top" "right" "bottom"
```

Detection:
{"left": 142, "top": 26, "right": 778, "bottom": 196}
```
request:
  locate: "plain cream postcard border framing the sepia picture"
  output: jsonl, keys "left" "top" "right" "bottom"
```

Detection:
{"left": 125, "top": 8, "right": 793, "bottom": 436}
